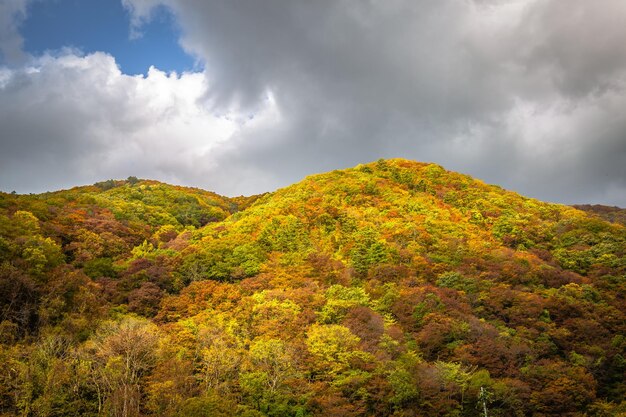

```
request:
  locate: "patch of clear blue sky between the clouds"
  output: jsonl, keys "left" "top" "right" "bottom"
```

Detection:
{"left": 20, "top": 0, "right": 197, "bottom": 74}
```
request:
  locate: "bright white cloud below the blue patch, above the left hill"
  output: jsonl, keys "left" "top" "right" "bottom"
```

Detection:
{"left": 0, "top": 53, "right": 241, "bottom": 192}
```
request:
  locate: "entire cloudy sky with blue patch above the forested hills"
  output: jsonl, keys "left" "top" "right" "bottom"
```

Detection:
{"left": 0, "top": 0, "right": 626, "bottom": 207}
